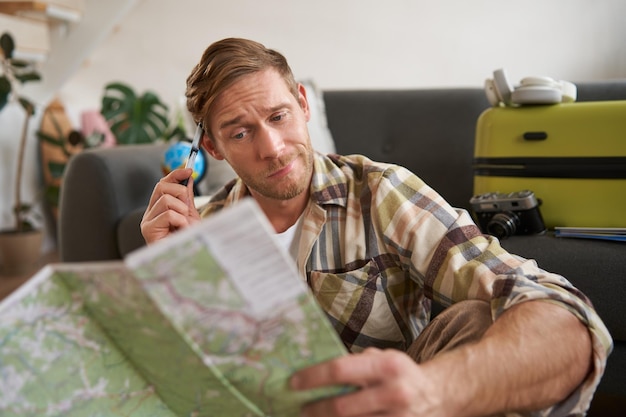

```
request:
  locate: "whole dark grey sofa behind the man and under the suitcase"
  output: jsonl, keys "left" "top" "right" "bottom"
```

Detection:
{"left": 58, "top": 80, "right": 626, "bottom": 416}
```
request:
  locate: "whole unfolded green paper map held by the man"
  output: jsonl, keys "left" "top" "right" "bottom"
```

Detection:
{"left": 0, "top": 203, "right": 346, "bottom": 417}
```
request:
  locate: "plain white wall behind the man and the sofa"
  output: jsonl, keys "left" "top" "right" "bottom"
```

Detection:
{"left": 0, "top": 0, "right": 626, "bottom": 245}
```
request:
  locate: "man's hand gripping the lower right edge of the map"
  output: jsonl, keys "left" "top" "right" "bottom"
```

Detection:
{"left": 291, "top": 348, "right": 446, "bottom": 417}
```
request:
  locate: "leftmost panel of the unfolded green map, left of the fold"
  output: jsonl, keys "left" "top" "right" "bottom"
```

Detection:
{"left": 0, "top": 267, "right": 175, "bottom": 417}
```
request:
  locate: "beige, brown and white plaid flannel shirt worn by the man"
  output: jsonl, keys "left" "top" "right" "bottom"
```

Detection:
{"left": 202, "top": 154, "right": 612, "bottom": 415}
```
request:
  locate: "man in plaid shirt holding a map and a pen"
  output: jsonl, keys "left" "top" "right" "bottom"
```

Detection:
{"left": 141, "top": 39, "right": 612, "bottom": 417}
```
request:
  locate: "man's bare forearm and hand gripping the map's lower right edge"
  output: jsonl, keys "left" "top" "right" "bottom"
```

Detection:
{"left": 291, "top": 300, "right": 593, "bottom": 417}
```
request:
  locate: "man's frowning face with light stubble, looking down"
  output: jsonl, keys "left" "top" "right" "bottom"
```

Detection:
{"left": 204, "top": 69, "right": 313, "bottom": 200}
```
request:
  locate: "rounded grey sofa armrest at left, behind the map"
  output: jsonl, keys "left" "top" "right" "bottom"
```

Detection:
{"left": 58, "top": 144, "right": 167, "bottom": 262}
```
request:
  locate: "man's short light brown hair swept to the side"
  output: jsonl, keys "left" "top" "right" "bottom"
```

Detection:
{"left": 185, "top": 38, "right": 298, "bottom": 139}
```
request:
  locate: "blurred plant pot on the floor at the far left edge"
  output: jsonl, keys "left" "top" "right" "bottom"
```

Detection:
{"left": 0, "top": 230, "right": 43, "bottom": 276}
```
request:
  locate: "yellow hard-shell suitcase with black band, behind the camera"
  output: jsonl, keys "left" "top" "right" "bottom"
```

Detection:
{"left": 474, "top": 101, "right": 626, "bottom": 228}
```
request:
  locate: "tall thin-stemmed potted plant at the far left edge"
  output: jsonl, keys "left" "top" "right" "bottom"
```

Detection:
{"left": 0, "top": 33, "right": 43, "bottom": 274}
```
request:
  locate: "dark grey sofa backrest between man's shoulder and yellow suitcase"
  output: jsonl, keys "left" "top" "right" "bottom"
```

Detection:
{"left": 324, "top": 88, "right": 489, "bottom": 208}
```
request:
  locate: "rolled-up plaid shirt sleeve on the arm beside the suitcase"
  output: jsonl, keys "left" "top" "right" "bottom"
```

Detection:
{"left": 376, "top": 164, "right": 613, "bottom": 415}
